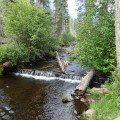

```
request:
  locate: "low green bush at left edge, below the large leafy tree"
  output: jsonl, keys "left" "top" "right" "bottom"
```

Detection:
{"left": 0, "top": 43, "right": 26, "bottom": 64}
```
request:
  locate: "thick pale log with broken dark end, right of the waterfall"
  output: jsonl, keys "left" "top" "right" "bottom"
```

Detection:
{"left": 71, "top": 69, "right": 95, "bottom": 98}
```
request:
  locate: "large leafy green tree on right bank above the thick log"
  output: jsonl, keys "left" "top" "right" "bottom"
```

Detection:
{"left": 74, "top": 0, "right": 116, "bottom": 72}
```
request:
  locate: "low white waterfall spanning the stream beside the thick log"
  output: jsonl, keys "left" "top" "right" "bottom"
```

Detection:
{"left": 13, "top": 69, "right": 82, "bottom": 83}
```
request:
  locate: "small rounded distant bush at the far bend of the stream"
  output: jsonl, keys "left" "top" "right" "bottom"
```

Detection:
{"left": 60, "top": 32, "right": 75, "bottom": 45}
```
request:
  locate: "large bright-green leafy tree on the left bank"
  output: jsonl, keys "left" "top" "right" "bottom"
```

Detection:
{"left": 4, "top": 0, "right": 57, "bottom": 60}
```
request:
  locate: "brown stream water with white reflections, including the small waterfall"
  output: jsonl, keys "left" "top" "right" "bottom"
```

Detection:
{"left": 0, "top": 46, "right": 87, "bottom": 120}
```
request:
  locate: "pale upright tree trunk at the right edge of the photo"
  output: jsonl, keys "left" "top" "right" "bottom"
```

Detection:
{"left": 115, "top": 0, "right": 120, "bottom": 67}
